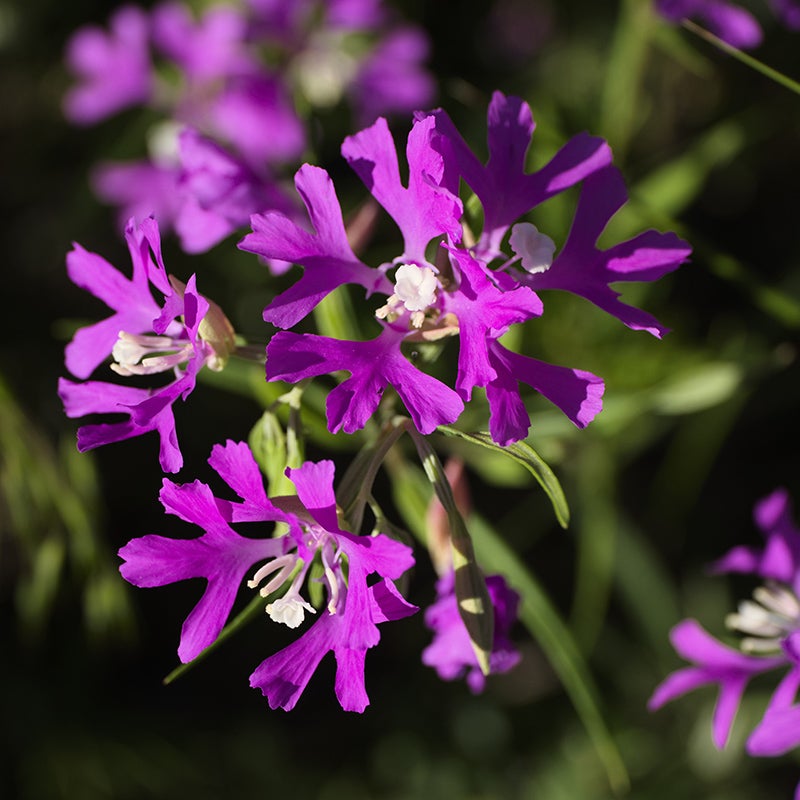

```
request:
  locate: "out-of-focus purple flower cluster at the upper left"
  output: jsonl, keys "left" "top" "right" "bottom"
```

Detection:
{"left": 64, "top": 0, "right": 433, "bottom": 253}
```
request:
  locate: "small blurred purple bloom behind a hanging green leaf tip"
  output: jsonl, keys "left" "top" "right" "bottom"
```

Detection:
{"left": 422, "top": 569, "right": 520, "bottom": 694}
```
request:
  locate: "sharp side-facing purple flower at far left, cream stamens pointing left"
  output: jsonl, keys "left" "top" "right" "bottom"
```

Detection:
{"left": 58, "top": 218, "right": 234, "bottom": 472}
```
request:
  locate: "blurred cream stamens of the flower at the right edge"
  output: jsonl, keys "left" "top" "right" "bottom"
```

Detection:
{"left": 725, "top": 583, "right": 800, "bottom": 653}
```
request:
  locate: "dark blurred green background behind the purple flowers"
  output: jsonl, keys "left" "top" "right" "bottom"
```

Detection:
{"left": 0, "top": 0, "right": 800, "bottom": 800}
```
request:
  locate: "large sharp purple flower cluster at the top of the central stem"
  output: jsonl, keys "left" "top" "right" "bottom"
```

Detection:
{"left": 239, "top": 92, "right": 690, "bottom": 445}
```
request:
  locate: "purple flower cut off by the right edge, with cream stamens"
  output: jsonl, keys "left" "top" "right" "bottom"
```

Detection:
{"left": 648, "top": 489, "right": 800, "bottom": 780}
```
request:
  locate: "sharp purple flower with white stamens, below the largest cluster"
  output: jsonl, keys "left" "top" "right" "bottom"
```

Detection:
{"left": 120, "top": 441, "right": 417, "bottom": 712}
